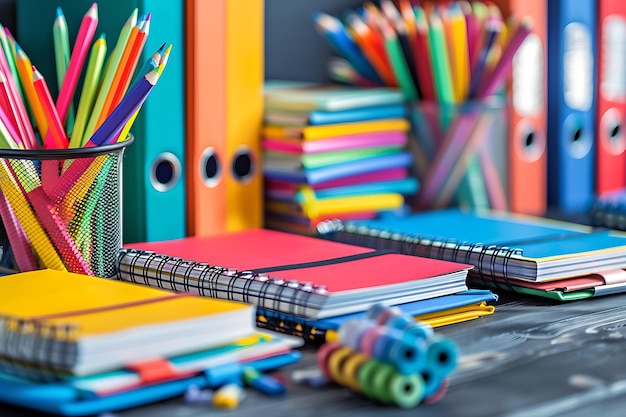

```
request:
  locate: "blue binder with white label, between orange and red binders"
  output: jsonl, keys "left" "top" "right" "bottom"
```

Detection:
{"left": 546, "top": 0, "right": 597, "bottom": 213}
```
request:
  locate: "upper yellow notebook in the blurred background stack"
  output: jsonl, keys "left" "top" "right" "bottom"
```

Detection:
{"left": 261, "top": 119, "right": 409, "bottom": 140}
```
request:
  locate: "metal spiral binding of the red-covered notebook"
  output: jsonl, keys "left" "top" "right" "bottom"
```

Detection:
{"left": 117, "top": 248, "right": 327, "bottom": 315}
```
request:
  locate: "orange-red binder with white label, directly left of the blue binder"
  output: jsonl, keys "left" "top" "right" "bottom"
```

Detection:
{"left": 494, "top": 0, "right": 548, "bottom": 215}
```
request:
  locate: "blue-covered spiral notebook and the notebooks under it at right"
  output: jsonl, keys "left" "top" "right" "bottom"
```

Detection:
{"left": 318, "top": 209, "right": 626, "bottom": 301}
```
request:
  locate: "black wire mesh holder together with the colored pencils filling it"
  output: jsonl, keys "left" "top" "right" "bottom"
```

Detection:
{"left": 0, "top": 3, "right": 171, "bottom": 277}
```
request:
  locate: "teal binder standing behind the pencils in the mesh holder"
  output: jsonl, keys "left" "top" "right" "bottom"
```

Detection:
{"left": 16, "top": 0, "right": 186, "bottom": 242}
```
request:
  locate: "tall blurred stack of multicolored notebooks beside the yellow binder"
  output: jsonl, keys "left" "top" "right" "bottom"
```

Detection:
{"left": 261, "top": 81, "right": 418, "bottom": 234}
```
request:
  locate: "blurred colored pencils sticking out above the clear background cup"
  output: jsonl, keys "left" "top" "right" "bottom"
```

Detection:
{"left": 313, "top": 0, "right": 532, "bottom": 103}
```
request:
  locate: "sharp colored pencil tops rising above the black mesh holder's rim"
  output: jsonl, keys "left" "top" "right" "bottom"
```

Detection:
{"left": 0, "top": 3, "right": 171, "bottom": 149}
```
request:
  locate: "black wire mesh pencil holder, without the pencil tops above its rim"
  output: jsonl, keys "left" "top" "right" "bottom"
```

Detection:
{"left": 0, "top": 136, "right": 133, "bottom": 278}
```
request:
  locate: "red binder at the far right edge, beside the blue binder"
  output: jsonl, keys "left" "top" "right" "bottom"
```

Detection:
{"left": 596, "top": 0, "right": 626, "bottom": 194}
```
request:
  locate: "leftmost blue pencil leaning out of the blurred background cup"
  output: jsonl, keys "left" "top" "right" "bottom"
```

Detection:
{"left": 313, "top": 12, "right": 383, "bottom": 85}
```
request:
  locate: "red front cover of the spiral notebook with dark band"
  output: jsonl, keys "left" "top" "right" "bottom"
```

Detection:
{"left": 127, "top": 229, "right": 471, "bottom": 293}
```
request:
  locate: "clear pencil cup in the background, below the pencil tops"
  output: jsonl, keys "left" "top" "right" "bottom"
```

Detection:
{"left": 411, "top": 96, "right": 508, "bottom": 211}
